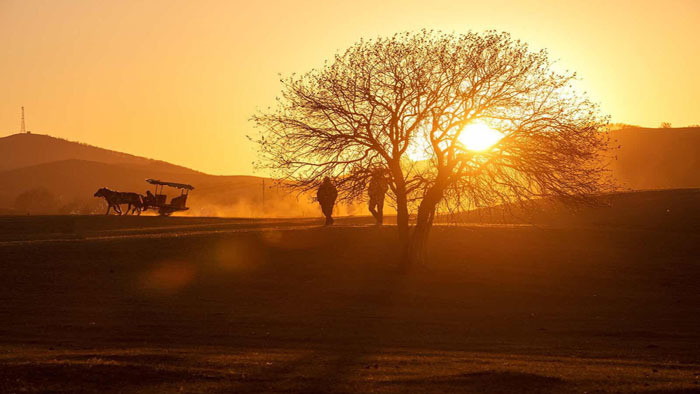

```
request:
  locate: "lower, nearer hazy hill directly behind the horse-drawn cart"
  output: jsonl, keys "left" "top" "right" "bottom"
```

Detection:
{"left": 0, "top": 159, "right": 318, "bottom": 216}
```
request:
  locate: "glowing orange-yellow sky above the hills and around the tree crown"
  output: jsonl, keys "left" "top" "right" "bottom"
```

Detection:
{"left": 0, "top": 0, "right": 700, "bottom": 174}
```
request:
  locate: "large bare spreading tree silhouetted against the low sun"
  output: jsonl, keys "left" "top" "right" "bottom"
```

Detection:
{"left": 253, "top": 31, "right": 607, "bottom": 261}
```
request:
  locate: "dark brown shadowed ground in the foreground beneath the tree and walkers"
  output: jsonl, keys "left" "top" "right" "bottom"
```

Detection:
{"left": 0, "top": 217, "right": 700, "bottom": 393}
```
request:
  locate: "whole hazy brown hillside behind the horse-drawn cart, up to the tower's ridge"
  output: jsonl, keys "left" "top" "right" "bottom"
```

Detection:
{"left": 0, "top": 134, "right": 312, "bottom": 216}
